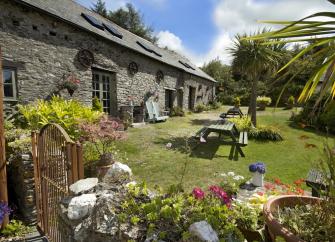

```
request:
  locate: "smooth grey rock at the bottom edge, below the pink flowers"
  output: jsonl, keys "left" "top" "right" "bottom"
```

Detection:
{"left": 188, "top": 221, "right": 219, "bottom": 242}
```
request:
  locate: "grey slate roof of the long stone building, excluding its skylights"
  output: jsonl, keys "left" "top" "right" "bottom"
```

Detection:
{"left": 15, "top": 0, "right": 216, "bottom": 82}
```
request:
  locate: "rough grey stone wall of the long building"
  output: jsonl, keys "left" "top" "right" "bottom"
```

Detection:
{"left": 0, "top": 0, "right": 214, "bottom": 113}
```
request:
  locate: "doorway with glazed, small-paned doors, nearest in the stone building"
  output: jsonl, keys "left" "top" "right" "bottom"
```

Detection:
{"left": 92, "top": 70, "right": 117, "bottom": 116}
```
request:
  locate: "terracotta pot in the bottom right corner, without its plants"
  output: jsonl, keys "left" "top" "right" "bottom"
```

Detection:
{"left": 263, "top": 195, "right": 322, "bottom": 242}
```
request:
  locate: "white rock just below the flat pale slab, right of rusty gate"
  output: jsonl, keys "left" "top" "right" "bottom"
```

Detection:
{"left": 67, "top": 194, "right": 97, "bottom": 220}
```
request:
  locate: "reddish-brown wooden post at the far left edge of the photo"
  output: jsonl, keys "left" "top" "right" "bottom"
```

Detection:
{"left": 0, "top": 46, "right": 9, "bottom": 226}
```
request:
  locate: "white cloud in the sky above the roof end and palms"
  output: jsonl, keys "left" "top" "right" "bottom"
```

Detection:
{"left": 158, "top": 0, "right": 334, "bottom": 65}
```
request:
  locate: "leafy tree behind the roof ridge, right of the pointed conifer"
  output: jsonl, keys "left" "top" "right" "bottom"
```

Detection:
{"left": 108, "top": 3, "right": 157, "bottom": 43}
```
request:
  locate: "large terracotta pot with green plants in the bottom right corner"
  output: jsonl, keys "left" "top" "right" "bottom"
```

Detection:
{"left": 263, "top": 144, "right": 335, "bottom": 242}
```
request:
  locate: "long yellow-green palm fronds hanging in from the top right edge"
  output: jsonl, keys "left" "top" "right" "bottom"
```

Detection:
{"left": 248, "top": 0, "right": 335, "bottom": 107}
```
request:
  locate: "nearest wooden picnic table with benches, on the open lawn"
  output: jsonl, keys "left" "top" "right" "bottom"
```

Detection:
{"left": 195, "top": 120, "right": 248, "bottom": 160}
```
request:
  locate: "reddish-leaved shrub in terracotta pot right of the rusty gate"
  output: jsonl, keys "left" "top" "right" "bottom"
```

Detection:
{"left": 80, "top": 116, "right": 125, "bottom": 178}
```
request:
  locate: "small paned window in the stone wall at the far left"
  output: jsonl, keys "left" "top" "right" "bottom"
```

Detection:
{"left": 3, "top": 67, "right": 17, "bottom": 101}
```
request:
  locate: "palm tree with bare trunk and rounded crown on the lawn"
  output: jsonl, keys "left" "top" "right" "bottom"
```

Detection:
{"left": 228, "top": 30, "right": 284, "bottom": 126}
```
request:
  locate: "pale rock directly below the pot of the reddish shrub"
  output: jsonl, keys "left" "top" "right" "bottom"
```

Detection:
{"left": 103, "top": 162, "right": 132, "bottom": 183}
